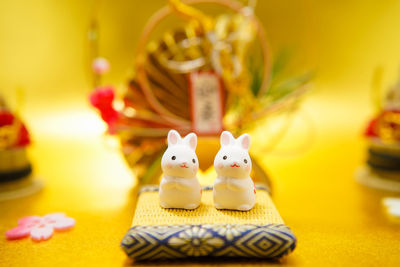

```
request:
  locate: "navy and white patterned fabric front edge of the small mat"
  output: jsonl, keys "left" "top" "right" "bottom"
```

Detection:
{"left": 122, "top": 224, "right": 296, "bottom": 260}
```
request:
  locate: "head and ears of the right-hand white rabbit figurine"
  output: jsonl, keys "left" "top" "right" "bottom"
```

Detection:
{"left": 214, "top": 131, "right": 251, "bottom": 178}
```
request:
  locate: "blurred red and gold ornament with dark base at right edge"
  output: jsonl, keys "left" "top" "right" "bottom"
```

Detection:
{"left": 358, "top": 72, "right": 400, "bottom": 191}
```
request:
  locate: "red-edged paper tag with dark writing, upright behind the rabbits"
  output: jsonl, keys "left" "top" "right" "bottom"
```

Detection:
{"left": 189, "top": 71, "right": 223, "bottom": 135}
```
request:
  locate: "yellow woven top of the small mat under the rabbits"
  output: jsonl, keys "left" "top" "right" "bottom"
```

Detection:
{"left": 132, "top": 190, "right": 283, "bottom": 226}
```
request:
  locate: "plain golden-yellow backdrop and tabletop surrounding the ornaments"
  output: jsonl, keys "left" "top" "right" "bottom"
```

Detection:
{"left": 0, "top": 0, "right": 400, "bottom": 266}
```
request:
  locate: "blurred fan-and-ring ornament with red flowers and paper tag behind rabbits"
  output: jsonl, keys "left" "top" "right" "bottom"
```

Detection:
{"left": 89, "top": 0, "right": 311, "bottom": 183}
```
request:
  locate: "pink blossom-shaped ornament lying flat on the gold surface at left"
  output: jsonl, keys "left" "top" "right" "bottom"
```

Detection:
{"left": 6, "top": 212, "right": 75, "bottom": 241}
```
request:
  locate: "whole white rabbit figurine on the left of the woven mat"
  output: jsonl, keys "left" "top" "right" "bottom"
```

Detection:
{"left": 159, "top": 130, "right": 201, "bottom": 210}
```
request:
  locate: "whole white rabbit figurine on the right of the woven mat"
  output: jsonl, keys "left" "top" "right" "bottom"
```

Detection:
{"left": 213, "top": 131, "right": 256, "bottom": 210}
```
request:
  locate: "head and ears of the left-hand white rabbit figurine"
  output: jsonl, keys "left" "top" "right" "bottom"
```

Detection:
{"left": 161, "top": 130, "right": 199, "bottom": 178}
